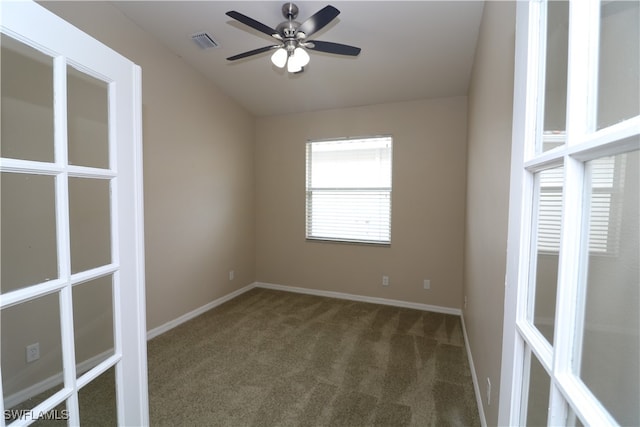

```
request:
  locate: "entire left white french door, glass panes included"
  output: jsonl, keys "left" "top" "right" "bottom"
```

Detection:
{"left": 0, "top": 1, "right": 148, "bottom": 426}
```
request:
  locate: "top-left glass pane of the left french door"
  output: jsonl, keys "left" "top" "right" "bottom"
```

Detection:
{"left": 0, "top": 34, "right": 54, "bottom": 162}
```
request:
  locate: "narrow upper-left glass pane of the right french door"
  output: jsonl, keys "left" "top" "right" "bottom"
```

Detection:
{"left": 537, "top": 1, "right": 569, "bottom": 152}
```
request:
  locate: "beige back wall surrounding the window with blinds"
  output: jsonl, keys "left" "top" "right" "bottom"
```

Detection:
{"left": 256, "top": 97, "right": 467, "bottom": 308}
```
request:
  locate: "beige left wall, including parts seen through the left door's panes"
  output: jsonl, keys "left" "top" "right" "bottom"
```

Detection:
{"left": 2, "top": 2, "right": 255, "bottom": 395}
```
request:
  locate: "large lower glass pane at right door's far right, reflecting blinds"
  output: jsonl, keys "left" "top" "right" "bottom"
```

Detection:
{"left": 578, "top": 149, "right": 640, "bottom": 425}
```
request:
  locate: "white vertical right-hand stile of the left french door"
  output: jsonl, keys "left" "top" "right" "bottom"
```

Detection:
{"left": 115, "top": 63, "right": 149, "bottom": 425}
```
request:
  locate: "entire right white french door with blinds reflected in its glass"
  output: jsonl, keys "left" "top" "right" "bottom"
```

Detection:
{"left": 499, "top": 0, "right": 640, "bottom": 426}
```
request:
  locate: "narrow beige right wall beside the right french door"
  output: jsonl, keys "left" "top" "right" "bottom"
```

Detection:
{"left": 464, "top": 2, "right": 516, "bottom": 425}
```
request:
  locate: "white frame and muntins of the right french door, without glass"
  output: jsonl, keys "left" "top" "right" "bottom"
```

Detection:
{"left": 498, "top": 0, "right": 640, "bottom": 425}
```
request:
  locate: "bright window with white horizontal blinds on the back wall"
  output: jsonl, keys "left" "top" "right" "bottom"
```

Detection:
{"left": 306, "top": 136, "right": 392, "bottom": 245}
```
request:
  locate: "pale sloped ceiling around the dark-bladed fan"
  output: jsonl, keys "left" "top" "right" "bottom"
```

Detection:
{"left": 113, "top": 0, "right": 483, "bottom": 116}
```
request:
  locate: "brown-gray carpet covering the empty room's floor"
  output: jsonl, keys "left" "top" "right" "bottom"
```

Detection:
{"left": 8, "top": 288, "right": 480, "bottom": 426}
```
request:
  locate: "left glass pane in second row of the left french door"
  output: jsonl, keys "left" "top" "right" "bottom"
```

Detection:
{"left": 0, "top": 172, "right": 58, "bottom": 293}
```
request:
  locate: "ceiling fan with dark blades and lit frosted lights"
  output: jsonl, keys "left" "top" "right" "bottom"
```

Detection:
{"left": 227, "top": 3, "right": 360, "bottom": 73}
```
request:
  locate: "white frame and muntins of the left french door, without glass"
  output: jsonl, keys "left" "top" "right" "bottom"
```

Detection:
{"left": 0, "top": 1, "right": 149, "bottom": 426}
